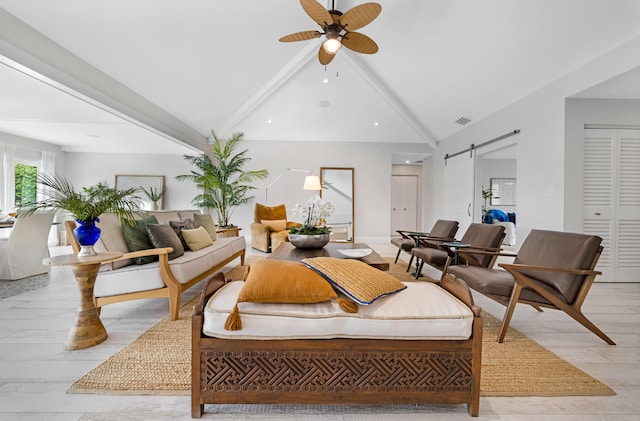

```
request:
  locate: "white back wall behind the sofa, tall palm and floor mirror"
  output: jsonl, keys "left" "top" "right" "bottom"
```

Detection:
{"left": 66, "top": 140, "right": 427, "bottom": 242}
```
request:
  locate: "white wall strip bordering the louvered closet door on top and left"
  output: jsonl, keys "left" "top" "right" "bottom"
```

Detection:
{"left": 564, "top": 99, "right": 640, "bottom": 231}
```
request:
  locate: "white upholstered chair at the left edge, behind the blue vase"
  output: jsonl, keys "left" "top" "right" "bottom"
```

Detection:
{"left": 0, "top": 212, "right": 55, "bottom": 280}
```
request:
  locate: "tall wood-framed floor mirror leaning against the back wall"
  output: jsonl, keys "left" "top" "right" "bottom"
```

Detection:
{"left": 320, "top": 167, "right": 354, "bottom": 243}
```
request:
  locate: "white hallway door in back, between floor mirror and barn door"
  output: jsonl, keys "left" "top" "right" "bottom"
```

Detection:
{"left": 391, "top": 175, "right": 418, "bottom": 235}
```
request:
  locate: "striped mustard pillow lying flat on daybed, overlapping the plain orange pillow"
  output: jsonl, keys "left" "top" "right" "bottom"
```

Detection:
{"left": 302, "top": 257, "right": 406, "bottom": 305}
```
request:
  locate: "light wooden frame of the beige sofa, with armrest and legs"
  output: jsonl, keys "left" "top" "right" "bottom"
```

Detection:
{"left": 65, "top": 221, "right": 245, "bottom": 321}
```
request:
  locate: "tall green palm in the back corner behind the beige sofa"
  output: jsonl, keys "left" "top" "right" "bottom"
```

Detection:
{"left": 176, "top": 131, "right": 269, "bottom": 228}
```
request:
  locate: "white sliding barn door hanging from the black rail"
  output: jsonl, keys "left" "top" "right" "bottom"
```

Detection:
{"left": 439, "top": 152, "right": 476, "bottom": 239}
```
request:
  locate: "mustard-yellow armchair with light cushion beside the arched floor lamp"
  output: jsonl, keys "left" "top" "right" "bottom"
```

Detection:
{"left": 250, "top": 203, "right": 301, "bottom": 253}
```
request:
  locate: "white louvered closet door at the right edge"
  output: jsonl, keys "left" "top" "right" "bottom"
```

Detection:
{"left": 583, "top": 129, "right": 640, "bottom": 282}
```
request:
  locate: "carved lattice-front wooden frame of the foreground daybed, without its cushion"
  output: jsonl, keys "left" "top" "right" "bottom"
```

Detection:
{"left": 191, "top": 273, "right": 482, "bottom": 418}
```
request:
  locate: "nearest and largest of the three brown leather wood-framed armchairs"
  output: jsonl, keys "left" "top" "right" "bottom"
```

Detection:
{"left": 446, "top": 229, "right": 615, "bottom": 345}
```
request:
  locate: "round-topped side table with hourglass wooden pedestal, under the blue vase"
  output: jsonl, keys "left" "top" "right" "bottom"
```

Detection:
{"left": 42, "top": 253, "right": 122, "bottom": 351}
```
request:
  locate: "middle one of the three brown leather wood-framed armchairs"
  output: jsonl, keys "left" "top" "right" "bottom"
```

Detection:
{"left": 407, "top": 223, "right": 504, "bottom": 278}
